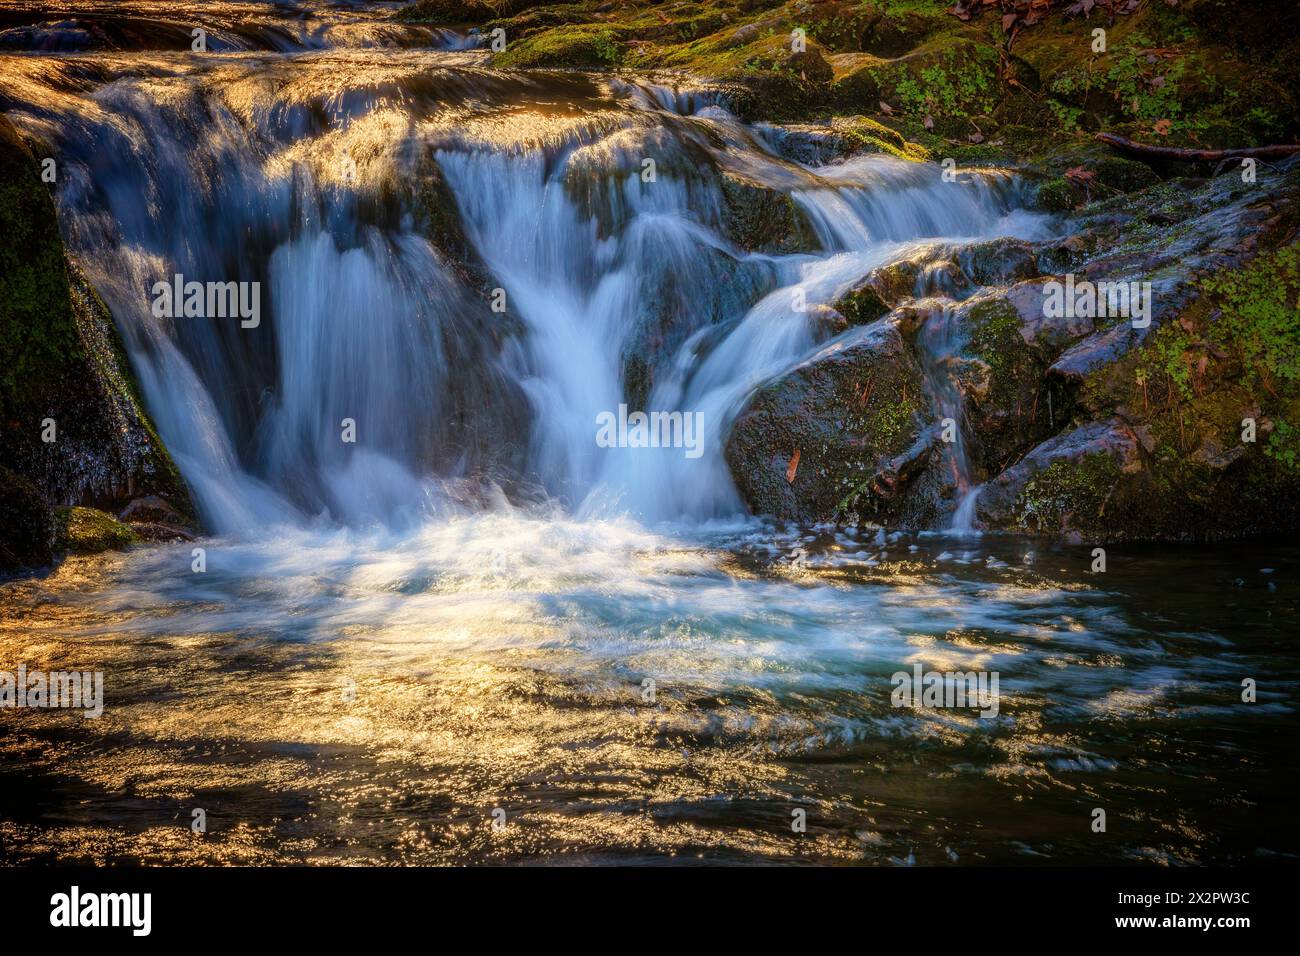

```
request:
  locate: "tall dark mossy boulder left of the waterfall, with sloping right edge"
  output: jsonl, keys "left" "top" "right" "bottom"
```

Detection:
{"left": 0, "top": 116, "right": 191, "bottom": 572}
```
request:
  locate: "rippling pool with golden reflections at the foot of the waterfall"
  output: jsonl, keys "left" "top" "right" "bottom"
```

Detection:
{"left": 0, "top": 509, "right": 1300, "bottom": 865}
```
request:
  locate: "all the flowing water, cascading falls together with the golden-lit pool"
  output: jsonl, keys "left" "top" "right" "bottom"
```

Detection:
{"left": 0, "top": 4, "right": 1300, "bottom": 865}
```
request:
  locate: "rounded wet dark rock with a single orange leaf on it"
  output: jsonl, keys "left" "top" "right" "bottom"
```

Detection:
{"left": 725, "top": 320, "right": 932, "bottom": 520}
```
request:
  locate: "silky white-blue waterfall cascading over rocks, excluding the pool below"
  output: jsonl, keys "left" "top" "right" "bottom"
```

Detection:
{"left": 7, "top": 42, "right": 1043, "bottom": 533}
